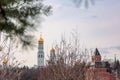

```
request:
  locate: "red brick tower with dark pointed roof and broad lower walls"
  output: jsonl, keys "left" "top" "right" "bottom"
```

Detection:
{"left": 86, "top": 48, "right": 119, "bottom": 80}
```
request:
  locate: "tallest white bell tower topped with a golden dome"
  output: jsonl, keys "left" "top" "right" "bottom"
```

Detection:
{"left": 37, "top": 35, "right": 45, "bottom": 68}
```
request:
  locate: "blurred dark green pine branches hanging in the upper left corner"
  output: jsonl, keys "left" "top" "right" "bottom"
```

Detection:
{"left": 0, "top": 0, "right": 51, "bottom": 45}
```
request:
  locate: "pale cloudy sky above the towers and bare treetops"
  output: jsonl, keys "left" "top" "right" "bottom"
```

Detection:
{"left": 16, "top": 0, "right": 120, "bottom": 66}
